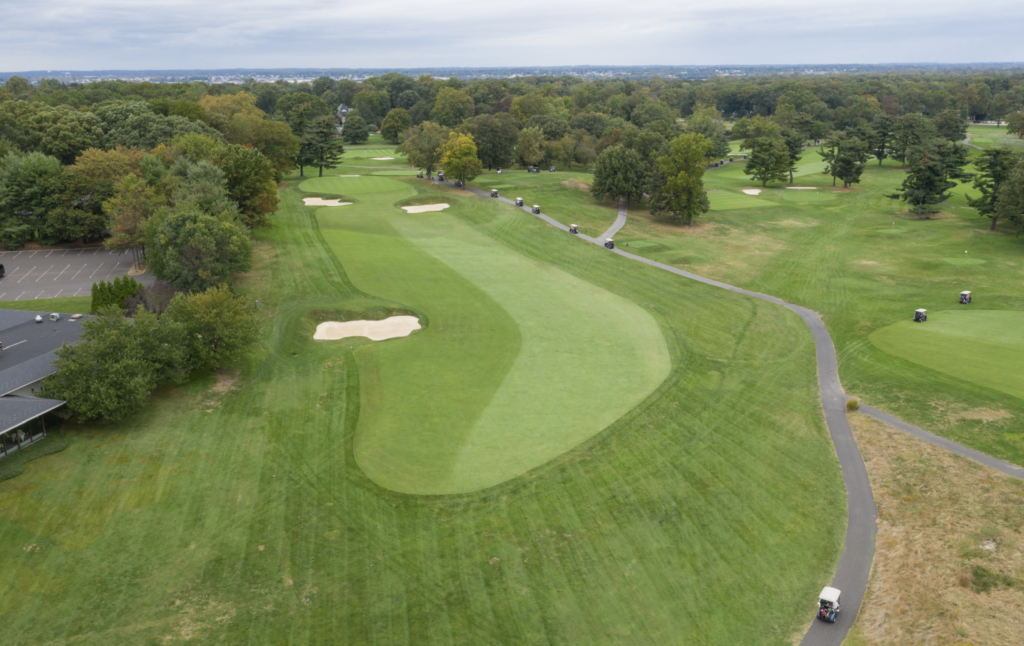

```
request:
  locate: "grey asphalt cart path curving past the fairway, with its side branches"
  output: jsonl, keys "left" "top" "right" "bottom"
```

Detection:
{"left": 456, "top": 182, "right": 1024, "bottom": 646}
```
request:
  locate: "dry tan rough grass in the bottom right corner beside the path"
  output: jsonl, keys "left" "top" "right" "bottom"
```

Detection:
{"left": 850, "top": 414, "right": 1024, "bottom": 646}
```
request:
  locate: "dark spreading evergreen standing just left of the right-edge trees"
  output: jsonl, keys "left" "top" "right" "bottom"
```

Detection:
{"left": 886, "top": 139, "right": 969, "bottom": 217}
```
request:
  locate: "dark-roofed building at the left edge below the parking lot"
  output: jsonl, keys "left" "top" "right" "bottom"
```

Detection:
{"left": 0, "top": 309, "right": 82, "bottom": 457}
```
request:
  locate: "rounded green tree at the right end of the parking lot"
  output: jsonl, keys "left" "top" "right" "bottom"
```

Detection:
{"left": 146, "top": 203, "right": 252, "bottom": 291}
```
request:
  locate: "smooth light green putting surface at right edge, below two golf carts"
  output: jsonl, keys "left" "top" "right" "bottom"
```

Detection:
{"left": 869, "top": 305, "right": 1024, "bottom": 398}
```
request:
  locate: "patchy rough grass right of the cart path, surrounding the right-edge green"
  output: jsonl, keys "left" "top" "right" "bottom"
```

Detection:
{"left": 618, "top": 152, "right": 1024, "bottom": 464}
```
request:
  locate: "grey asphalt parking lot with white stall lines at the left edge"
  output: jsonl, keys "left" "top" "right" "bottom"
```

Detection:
{"left": 0, "top": 249, "right": 153, "bottom": 301}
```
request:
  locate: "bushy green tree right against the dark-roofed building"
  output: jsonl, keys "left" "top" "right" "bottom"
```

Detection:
{"left": 43, "top": 307, "right": 184, "bottom": 422}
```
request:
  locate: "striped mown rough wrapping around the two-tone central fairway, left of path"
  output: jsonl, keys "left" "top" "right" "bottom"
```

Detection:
{"left": 0, "top": 167, "right": 845, "bottom": 646}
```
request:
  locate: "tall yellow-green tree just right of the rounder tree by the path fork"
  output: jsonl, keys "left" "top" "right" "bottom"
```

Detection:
{"left": 650, "top": 134, "right": 713, "bottom": 226}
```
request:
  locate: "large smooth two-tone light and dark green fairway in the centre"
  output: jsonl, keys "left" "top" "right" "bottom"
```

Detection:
{"left": 302, "top": 178, "right": 671, "bottom": 494}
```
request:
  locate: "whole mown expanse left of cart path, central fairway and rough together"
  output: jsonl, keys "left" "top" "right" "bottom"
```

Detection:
{"left": 0, "top": 165, "right": 846, "bottom": 646}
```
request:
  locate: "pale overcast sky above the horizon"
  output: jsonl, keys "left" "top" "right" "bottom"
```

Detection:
{"left": 0, "top": 0, "right": 1024, "bottom": 72}
